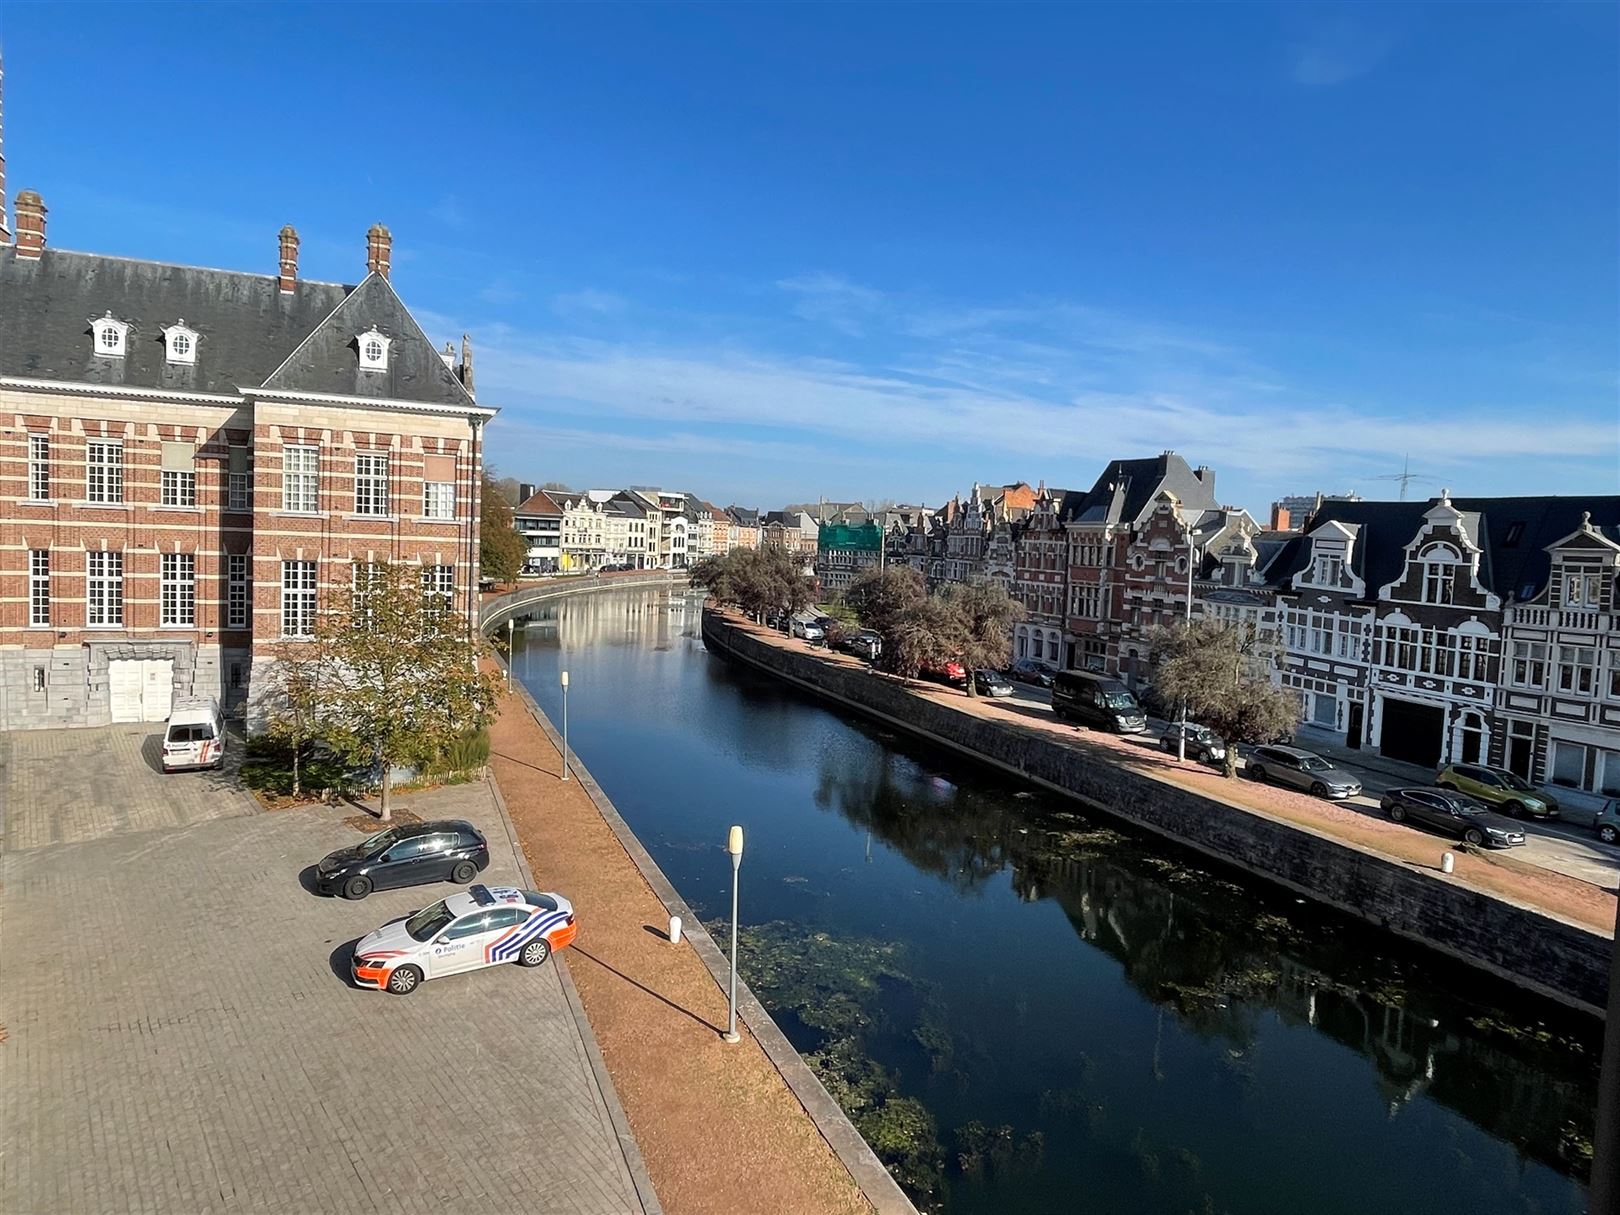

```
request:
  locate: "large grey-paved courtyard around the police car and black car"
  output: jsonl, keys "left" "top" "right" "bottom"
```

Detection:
{"left": 0, "top": 751, "right": 643, "bottom": 1215}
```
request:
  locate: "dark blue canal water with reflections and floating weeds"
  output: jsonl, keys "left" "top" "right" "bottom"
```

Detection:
{"left": 514, "top": 591, "right": 1599, "bottom": 1215}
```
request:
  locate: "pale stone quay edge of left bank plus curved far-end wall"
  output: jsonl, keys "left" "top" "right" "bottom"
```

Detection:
{"left": 480, "top": 570, "right": 917, "bottom": 1215}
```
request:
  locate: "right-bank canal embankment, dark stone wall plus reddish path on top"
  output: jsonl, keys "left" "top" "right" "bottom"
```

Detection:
{"left": 703, "top": 608, "right": 1614, "bottom": 1016}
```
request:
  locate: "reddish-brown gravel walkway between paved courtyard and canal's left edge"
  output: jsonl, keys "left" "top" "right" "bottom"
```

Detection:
{"left": 491, "top": 677, "right": 910, "bottom": 1215}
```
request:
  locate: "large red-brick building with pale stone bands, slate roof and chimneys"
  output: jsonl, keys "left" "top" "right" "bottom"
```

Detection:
{"left": 0, "top": 76, "right": 496, "bottom": 729}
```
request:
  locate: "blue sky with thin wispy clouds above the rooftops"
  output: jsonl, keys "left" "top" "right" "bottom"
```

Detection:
{"left": 0, "top": 3, "right": 1620, "bottom": 514}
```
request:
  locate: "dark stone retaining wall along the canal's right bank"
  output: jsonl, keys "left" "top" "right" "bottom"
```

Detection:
{"left": 703, "top": 608, "right": 1614, "bottom": 1016}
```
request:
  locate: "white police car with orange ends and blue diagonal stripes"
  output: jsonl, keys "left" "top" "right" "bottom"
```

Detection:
{"left": 350, "top": 886, "right": 578, "bottom": 996}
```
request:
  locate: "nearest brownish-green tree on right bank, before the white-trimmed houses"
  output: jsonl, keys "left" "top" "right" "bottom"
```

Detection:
{"left": 1147, "top": 620, "right": 1299, "bottom": 776}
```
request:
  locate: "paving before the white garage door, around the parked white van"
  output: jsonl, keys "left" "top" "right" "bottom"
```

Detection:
{"left": 0, "top": 726, "right": 258, "bottom": 852}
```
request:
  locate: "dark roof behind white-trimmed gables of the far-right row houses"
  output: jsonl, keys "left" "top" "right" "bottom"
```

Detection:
{"left": 1272, "top": 496, "right": 1620, "bottom": 603}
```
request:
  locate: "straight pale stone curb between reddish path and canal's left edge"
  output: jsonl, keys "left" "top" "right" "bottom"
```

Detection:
{"left": 497, "top": 667, "right": 919, "bottom": 1215}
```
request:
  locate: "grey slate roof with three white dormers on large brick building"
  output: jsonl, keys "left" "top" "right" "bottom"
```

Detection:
{"left": 0, "top": 246, "right": 473, "bottom": 407}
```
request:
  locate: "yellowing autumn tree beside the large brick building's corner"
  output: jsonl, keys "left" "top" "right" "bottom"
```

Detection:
{"left": 309, "top": 564, "right": 499, "bottom": 821}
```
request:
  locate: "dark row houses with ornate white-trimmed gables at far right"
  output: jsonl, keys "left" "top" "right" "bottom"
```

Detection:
{"left": 1277, "top": 494, "right": 1620, "bottom": 813}
